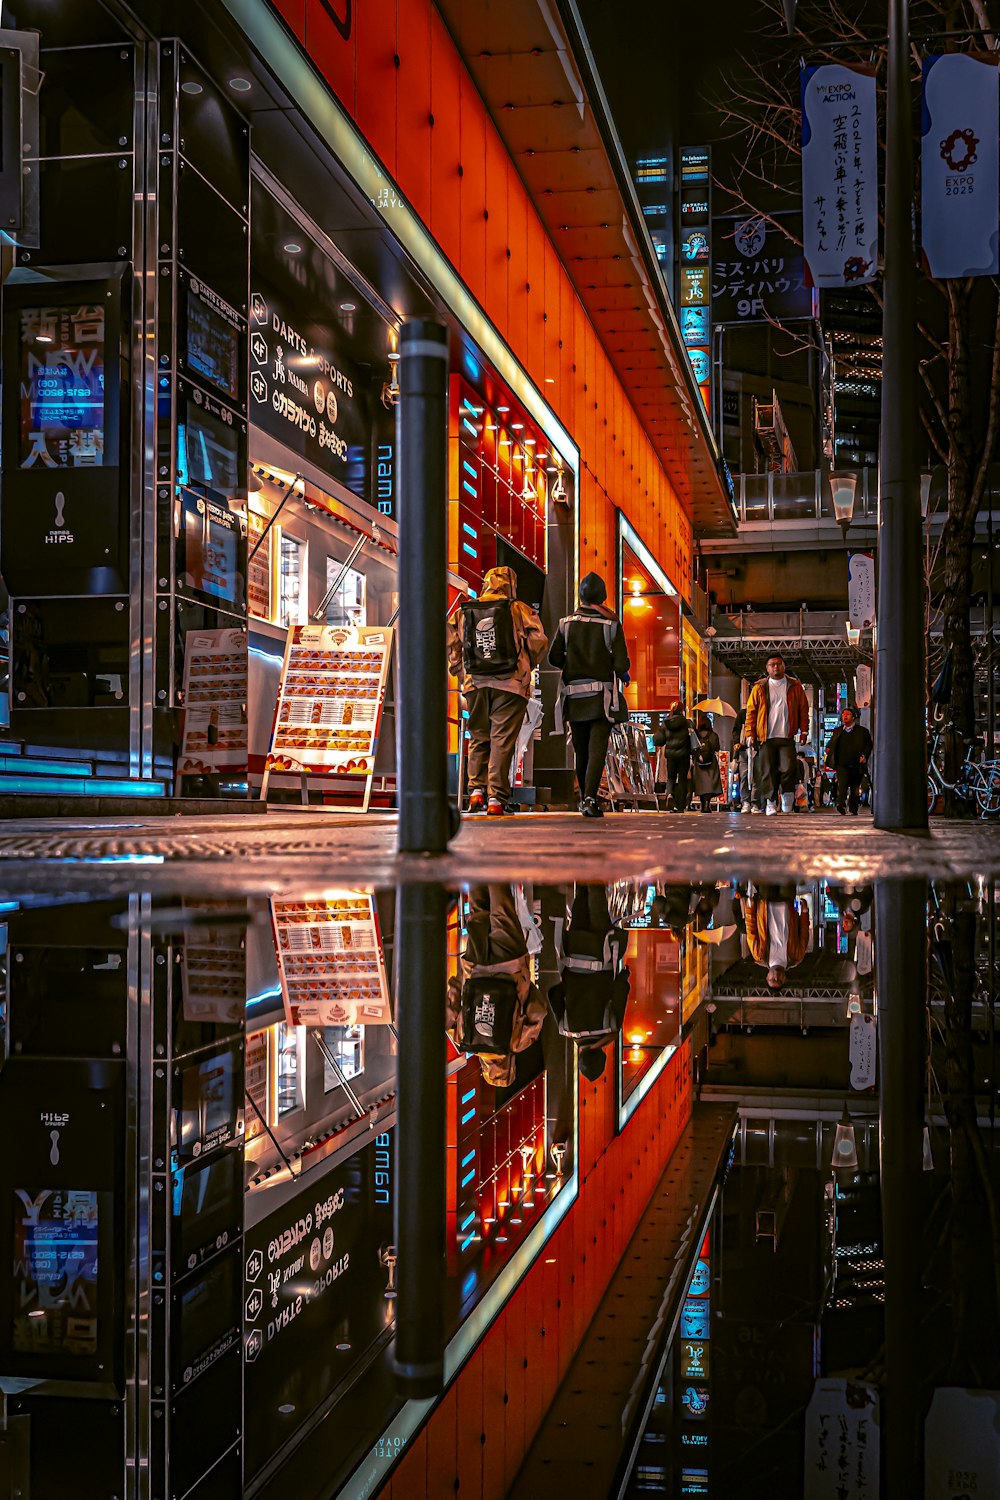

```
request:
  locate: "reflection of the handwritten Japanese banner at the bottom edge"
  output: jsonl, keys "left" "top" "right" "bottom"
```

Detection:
{"left": 804, "top": 1380, "right": 879, "bottom": 1500}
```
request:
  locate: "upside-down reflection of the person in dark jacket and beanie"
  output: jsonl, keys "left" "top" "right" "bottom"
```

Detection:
{"left": 549, "top": 885, "right": 630, "bottom": 1080}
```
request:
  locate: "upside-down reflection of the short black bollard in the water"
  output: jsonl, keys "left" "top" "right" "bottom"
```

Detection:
{"left": 393, "top": 882, "right": 448, "bottom": 1398}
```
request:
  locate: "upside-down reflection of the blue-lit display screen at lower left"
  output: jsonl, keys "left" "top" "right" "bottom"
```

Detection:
{"left": 10, "top": 1188, "right": 102, "bottom": 1356}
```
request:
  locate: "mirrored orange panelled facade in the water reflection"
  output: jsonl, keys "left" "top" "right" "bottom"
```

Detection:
{"left": 379, "top": 1044, "right": 691, "bottom": 1500}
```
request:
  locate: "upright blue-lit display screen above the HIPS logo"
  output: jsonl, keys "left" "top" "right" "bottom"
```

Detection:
{"left": 18, "top": 303, "right": 105, "bottom": 468}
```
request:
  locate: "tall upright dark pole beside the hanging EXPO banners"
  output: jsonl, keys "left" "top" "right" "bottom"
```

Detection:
{"left": 874, "top": 0, "right": 927, "bottom": 828}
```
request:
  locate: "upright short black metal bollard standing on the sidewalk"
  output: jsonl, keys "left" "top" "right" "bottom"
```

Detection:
{"left": 396, "top": 318, "right": 450, "bottom": 854}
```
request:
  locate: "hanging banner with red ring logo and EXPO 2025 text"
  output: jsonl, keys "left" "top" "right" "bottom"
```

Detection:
{"left": 921, "top": 53, "right": 1000, "bottom": 281}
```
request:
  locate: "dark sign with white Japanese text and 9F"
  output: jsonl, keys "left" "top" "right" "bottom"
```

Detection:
{"left": 712, "top": 215, "right": 819, "bottom": 324}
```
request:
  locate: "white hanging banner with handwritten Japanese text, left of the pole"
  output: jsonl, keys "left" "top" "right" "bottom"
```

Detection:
{"left": 801, "top": 63, "right": 879, "bottom": 288}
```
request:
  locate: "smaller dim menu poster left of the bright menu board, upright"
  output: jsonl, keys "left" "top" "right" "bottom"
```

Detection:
{"left": 177, "top": 630, "right": 247, "bottom": 776}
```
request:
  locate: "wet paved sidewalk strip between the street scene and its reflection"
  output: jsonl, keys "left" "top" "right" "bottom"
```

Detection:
{"left": 0, "top": 809, "right": 1000, "bottom": 894}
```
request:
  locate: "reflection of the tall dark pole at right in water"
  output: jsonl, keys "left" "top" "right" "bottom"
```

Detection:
{"left": 874, "top": 881, "right": 927, "bottom": 1496}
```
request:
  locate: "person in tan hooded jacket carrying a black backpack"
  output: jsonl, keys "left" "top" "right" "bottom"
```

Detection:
{"left": 448, "top": 567, "right": 549, "bottom": 818}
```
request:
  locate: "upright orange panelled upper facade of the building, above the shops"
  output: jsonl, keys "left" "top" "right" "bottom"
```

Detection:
{"left": 274, "top": 0, "right": 693, "bottom": 597}
